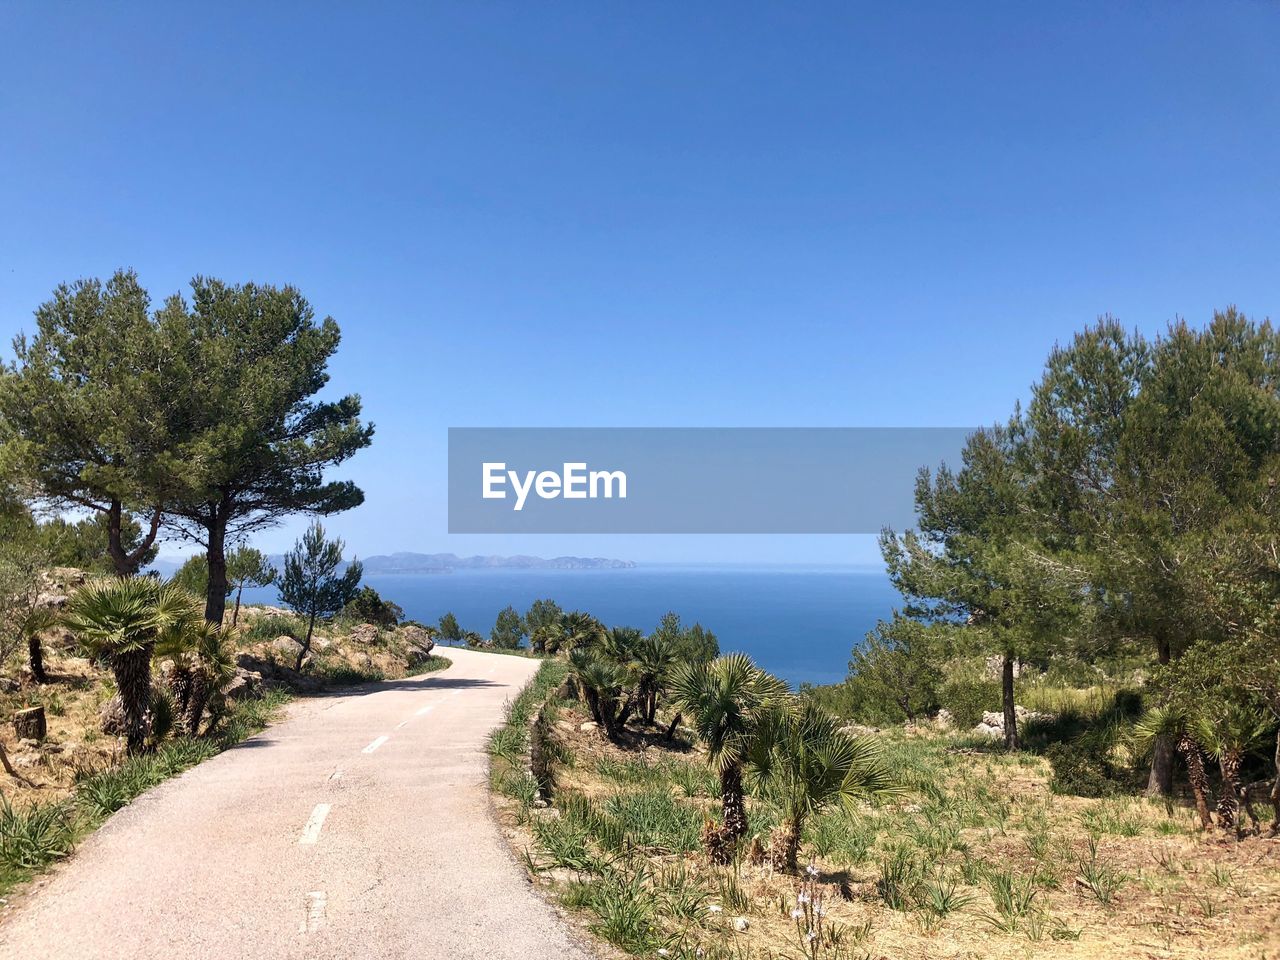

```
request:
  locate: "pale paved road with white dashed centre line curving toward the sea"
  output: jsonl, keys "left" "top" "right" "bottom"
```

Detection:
{"left": 0, "top": 649, "right": 589, "bottom": 960}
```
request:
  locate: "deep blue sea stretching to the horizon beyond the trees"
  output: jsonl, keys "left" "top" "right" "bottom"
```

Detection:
{"left": 246, "top": 564, "right": 901, "bottom": 684}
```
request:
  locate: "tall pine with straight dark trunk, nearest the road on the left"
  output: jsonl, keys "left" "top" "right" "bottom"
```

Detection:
{"left": 157, "top": 276, "right": 372, "bottom": 622}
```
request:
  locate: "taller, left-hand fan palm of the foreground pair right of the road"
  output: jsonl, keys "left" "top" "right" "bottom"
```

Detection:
{"left": 669, "top": 653, "right": 790, "bottom": 863}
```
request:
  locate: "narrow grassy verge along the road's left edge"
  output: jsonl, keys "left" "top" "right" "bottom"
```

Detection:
{"left": 0, "top": 691, "right": 289, "bottom": 895}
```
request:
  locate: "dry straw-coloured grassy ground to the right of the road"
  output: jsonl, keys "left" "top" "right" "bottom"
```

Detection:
{"left": 495, "top": 686, "right": 1280, "bottom": 960}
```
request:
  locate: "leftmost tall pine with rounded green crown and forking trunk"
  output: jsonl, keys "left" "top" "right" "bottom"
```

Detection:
{"left": 0, "top": 270, "right": 177, "bottom": 573}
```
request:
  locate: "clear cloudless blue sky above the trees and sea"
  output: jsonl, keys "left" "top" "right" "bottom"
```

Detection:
{"left": 0, "top": 1, "right": 1280, "bottom": 562}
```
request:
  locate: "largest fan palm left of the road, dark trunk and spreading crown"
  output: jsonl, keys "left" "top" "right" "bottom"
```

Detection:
{"left": 64, "top": 577, "right": 188, "bottom": 754}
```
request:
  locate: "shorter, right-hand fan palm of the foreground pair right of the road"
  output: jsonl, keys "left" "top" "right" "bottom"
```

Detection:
{"left": 746, "top": 703, "right": 899, "bottom": 870}
